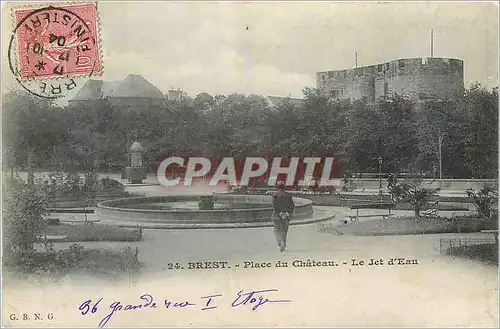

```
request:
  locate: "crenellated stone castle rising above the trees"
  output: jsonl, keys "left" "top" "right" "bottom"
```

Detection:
{"left": 316, "top": 57, "right": 464, "bottom": 102}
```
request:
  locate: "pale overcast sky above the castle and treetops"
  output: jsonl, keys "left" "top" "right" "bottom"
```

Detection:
{"left": 3, "top": 2, "right": 499, "bottom": 97}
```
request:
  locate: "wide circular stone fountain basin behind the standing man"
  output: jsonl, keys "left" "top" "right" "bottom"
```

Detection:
{"left": 96, "top": 195, "right": 313, "bottom": 226}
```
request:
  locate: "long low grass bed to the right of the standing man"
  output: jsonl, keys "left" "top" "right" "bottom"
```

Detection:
{"left": 336, "top": 217, "right": 494, "bottom": 235}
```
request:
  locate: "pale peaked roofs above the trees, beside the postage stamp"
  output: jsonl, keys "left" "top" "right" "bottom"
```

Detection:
{"left": 69, "top": 74, "right": 165, "bottom": 107}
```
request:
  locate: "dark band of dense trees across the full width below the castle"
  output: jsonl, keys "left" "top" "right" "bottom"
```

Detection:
{"left": 3, "top": 85, "right": 498, "bottom": 178}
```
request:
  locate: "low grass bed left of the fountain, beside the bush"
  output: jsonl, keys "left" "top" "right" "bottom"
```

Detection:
{"left": 47, "top": 223, "right": 142, "bottom": 242}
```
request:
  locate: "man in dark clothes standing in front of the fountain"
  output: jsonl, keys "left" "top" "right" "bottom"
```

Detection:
{"left": 273, "top": 181, "right": 295, "bottom": 252}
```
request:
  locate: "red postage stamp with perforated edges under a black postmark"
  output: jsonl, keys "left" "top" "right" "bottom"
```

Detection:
{"left": 13, "top": 3, "right": 102, "bottom": 80}
